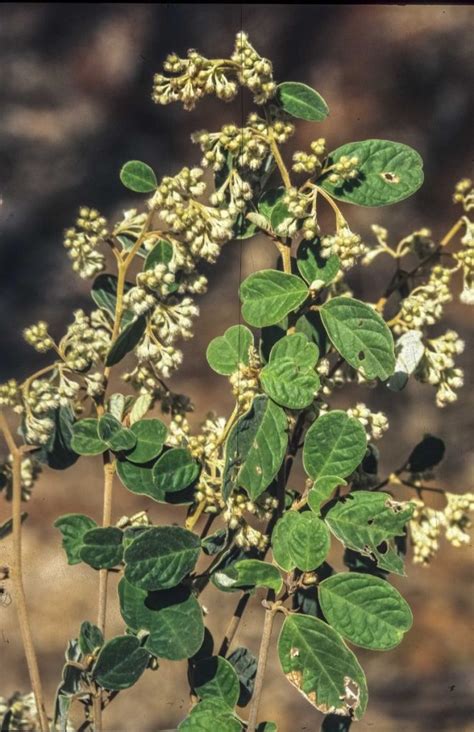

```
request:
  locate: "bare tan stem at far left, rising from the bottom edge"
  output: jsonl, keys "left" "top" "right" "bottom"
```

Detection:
{"left": 0, "top": 412, "right": 49, "bottom": 732}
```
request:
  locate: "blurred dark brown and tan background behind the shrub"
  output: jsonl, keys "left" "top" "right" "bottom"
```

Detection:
{"left": 0, "top": 3, "right": 474, "bottom": 732}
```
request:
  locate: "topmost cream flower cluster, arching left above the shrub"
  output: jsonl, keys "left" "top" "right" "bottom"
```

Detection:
{"left": 152, "top": 32, "right": 276, "bottom": 109}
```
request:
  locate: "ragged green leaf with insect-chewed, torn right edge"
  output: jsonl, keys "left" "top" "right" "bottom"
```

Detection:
{"left": 325, "top": 491, "right": 414, "bottom": 575}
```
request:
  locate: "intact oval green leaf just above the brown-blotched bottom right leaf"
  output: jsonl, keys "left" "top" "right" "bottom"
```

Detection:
{"left": 318, "top": 572, "right": 413, "bottom": 651}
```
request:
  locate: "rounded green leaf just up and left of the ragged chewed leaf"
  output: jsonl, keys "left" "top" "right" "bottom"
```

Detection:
{"left": 303, "top": 409, "right": 367, "bottom": 485}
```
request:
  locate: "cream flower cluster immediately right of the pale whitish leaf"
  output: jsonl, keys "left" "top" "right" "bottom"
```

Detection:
{"left": 415, "top": 330, "right": 464, "bottom": 407}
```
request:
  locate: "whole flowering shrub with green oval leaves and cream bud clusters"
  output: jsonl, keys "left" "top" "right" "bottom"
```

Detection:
{"left": 0, "top": 33, "right": 474, "bottom": 732}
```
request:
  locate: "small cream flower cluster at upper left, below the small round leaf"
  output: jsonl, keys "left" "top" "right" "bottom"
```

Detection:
{"left": 64, "top": 206, "right": 109, "bottom": 279}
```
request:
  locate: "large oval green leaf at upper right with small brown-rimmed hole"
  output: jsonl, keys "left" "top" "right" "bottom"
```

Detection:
{"left": 320, "top": 140, "right": 423, "bottom": 206}
